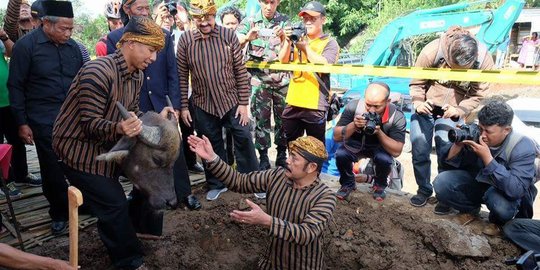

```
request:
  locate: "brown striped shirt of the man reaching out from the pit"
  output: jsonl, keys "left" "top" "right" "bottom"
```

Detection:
{"left": 208, "top": 160, "right": 336, "bottom": 269}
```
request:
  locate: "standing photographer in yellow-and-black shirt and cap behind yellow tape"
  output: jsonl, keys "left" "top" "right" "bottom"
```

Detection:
{"left": 279, "top": 1, "right": 339, "bottom": 142}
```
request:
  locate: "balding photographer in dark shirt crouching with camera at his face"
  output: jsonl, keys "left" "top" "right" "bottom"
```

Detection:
{"left": 334, "top": 82, "right": 406, "bottom": 201}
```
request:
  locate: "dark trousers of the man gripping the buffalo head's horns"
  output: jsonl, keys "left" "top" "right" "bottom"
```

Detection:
{"left": 63, "top": 165, "right": 143, "bottom": 269}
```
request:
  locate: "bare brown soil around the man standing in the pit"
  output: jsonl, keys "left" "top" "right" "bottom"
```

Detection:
{"left": 31, "top": 188, "right": 519, "bottom": 269}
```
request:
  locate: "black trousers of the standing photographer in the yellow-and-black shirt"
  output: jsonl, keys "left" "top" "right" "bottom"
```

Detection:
{"left": 282, "top": 118, "right": 326, "bottom": 143}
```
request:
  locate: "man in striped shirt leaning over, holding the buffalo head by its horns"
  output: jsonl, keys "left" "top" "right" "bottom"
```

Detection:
{"left": 53, "top": 17, "right": 171, "bottom": 269}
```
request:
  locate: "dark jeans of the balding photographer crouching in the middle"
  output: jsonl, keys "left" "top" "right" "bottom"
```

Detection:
{"left": 336, "top": 145, "right": 394, "bottom": 188}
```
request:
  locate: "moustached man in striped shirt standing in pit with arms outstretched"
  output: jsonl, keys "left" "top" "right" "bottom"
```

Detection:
{"left": 188, "top": 135, "right": 336, "bottom": 269}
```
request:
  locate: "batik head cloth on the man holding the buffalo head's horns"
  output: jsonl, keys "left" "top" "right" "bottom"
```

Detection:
{"left": 116, "top": 16, "right": 165, "bottom": 51}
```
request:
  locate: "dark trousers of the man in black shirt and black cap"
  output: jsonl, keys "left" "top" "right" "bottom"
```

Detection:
{"left": 30, "top": 125, "right": 68, "bottom": 221}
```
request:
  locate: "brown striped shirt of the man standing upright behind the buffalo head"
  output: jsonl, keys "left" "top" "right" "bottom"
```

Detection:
{"left": 176, "top": 25, "right": 250, "bottom": 118}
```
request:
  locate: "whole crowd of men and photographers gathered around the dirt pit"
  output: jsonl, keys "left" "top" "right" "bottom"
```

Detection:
{"left": 0, "top": 0, "right": 540, "bottom": 269}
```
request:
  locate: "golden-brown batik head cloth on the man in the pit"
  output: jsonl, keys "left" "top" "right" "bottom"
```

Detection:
{"left": 289, "top": 136, "right": 328, "bottom": 168}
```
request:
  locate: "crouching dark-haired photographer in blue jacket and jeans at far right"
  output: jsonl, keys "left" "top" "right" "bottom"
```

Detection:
{"left": 434, "top": 100, "right": 537, "bottom": 236}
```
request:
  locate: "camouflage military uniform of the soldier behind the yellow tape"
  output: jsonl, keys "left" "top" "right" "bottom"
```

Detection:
{"left": 237, "top": 12, "right": 290, "bottom": 165}
